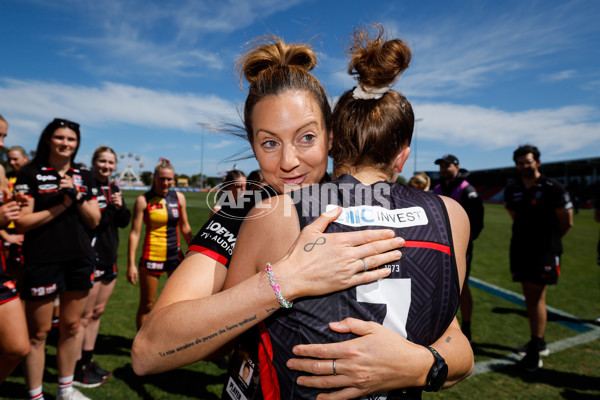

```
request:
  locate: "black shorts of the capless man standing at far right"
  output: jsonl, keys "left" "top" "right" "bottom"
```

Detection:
{"left": 510, "top": 251, "right": 560, "bottom": 285}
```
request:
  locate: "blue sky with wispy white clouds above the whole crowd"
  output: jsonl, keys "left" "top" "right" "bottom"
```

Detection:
{"left": 0, "top": 0, "right": 600, "bottom": 178}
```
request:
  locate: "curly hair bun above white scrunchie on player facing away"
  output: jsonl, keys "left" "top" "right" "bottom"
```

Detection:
{"left": 348, "top": 25, "right": 411, "bottom": 88}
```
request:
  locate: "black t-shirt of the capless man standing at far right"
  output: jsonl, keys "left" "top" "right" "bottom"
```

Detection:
{"left": 504, "top": 176, "right": 573, "bottom": 254}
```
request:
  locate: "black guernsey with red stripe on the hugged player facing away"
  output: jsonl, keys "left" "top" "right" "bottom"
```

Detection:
{"left": 260, "top": 175, "right": 460, "bottom": 400}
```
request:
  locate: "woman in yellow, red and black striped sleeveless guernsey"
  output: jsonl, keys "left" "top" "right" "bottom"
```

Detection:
{"left": 127, "top": 159, "right": 192, "bottom": 330}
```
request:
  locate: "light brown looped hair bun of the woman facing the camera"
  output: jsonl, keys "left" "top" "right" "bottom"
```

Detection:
{"left": 237, "top": 36, "right": 317, "bottom": 84}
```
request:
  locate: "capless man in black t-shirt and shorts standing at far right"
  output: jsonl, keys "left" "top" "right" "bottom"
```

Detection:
{"left": 504, "top": 144, "right": 573, "bottom": 371}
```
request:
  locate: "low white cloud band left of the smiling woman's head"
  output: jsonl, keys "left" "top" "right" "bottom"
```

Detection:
{"left": 0, "top": 80, "right": 238, "bottom": 134}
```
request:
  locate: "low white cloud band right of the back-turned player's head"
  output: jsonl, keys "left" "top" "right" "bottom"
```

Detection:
{"left": 413, "top": 103, "right": 600, "bottom": 154}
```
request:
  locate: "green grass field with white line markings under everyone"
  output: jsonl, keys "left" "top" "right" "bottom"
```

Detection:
{"left": 0, "top": 192, "right": 600, "bottom": 400}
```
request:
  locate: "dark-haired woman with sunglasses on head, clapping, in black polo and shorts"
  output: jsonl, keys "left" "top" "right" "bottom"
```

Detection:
{"left": 15, "top": 118, "right": 100, "bottom": 399}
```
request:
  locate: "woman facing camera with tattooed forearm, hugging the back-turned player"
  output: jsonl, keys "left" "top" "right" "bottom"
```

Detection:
{"left": 132, "top": 37, "right": 472, "bottom": 398}
